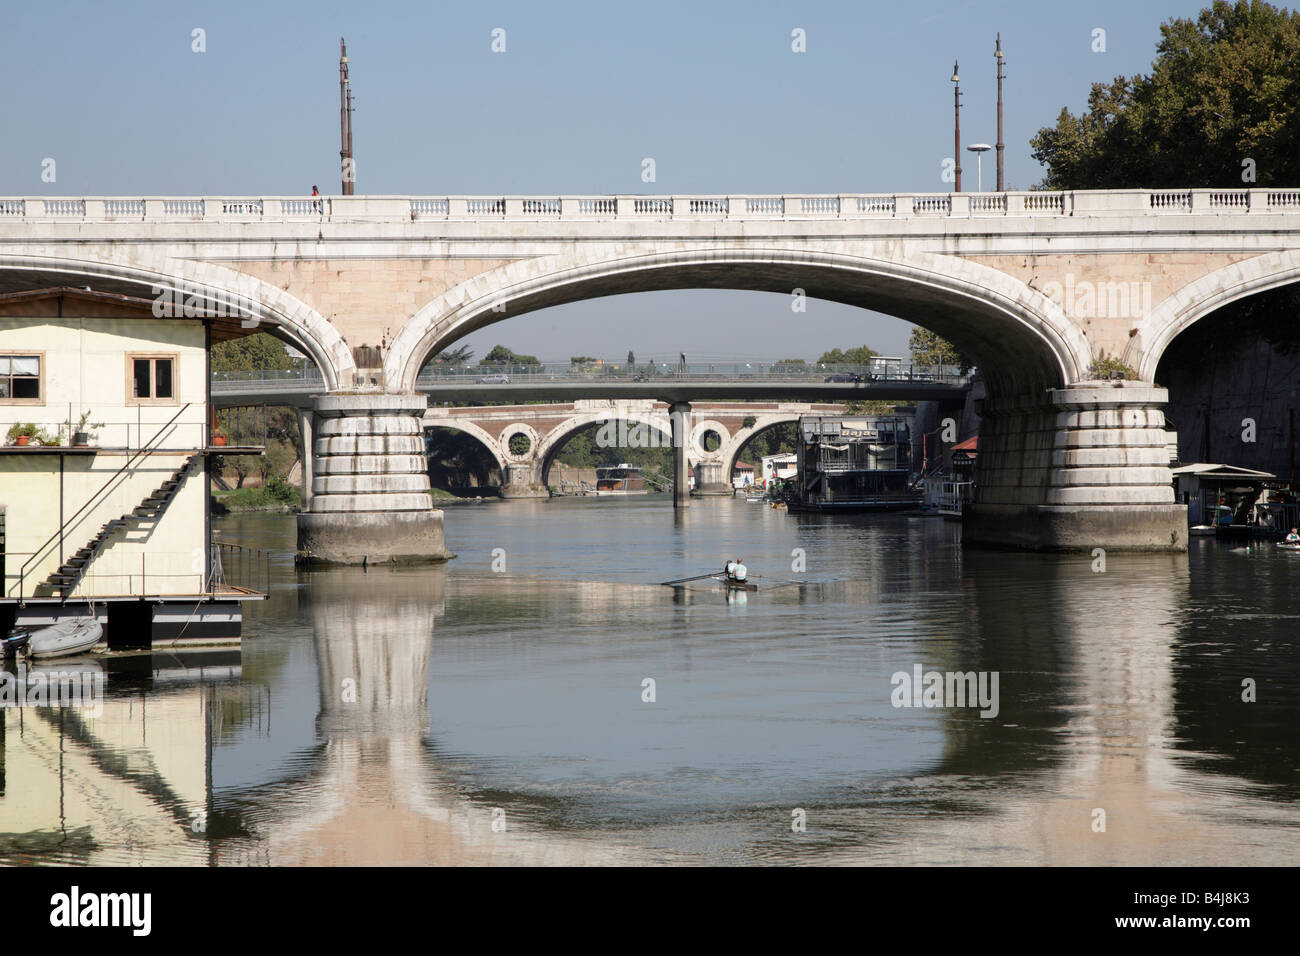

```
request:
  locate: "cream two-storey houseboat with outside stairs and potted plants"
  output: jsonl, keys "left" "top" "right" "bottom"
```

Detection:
{"left": 0, "top": 286, "right": 265, "bottom": 648}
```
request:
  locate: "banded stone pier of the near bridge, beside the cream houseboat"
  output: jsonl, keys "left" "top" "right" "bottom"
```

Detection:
{"left": 298, "top": 393, "right": 451, "bottom": 564}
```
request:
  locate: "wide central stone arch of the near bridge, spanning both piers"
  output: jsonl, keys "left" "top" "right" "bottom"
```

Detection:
{"left": 385, "top": 242, "right": 1092, "bottom": 392}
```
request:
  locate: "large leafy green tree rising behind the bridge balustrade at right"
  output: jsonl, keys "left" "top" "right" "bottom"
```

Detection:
{"left": 1030, "top": 0, "right": 1300, "bottom": 189}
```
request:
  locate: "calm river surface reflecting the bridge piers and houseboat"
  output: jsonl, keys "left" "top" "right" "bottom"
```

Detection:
{"left": 0, "top": 497, "right": 1300, "bottom": 865}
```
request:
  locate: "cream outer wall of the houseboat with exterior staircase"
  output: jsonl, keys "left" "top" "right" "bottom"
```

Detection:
{"left": 0, "top": 317, "right": 208, "bottom": 597}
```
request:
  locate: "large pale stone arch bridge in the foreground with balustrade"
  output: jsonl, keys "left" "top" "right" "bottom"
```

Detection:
{"left": 0, "top": 189, "right": 1300, "bottom": 561}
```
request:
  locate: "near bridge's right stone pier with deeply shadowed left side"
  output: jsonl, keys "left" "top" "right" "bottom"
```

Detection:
{"left": 962, "top": 381, "right": 1187, "bottom": 551}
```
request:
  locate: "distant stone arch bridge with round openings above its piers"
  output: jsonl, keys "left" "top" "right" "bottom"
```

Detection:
{"left": 424, "top": 399, "right": 844, "bottom": 498}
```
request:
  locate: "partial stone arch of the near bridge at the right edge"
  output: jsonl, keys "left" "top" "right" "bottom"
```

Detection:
{"left": 1123, "top": 250, "right": 1300, "bottom": 381}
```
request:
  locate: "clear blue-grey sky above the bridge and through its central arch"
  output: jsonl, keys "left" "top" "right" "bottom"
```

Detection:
{"left": 0, "top": 0, "right": 1209, "bottom": 360}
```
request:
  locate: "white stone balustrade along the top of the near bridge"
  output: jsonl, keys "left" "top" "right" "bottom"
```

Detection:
{"left": 0, "top": 189, "right": 1300, "bottom": 224}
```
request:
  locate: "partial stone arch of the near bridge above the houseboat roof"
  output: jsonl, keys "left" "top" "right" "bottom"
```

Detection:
{"left": 0, "top": 252, "right": 355, "bottom": 390}
